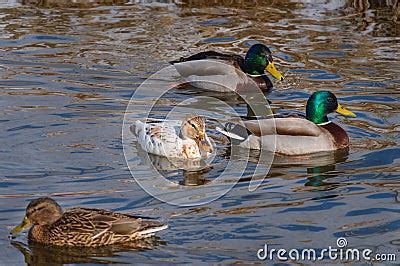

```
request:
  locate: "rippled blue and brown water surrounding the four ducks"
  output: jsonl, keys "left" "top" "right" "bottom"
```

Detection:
{"left": 0, "top": 0, "right": 400, "bottom": 264}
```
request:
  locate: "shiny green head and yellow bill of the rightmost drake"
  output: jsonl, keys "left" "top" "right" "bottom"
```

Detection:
{"left": 306, "top": 91, "right": 356, "bottom": 124}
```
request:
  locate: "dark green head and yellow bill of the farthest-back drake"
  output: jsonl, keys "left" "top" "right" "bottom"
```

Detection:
{"left": 243, "top": 43, "right": 283, "bottom": 80}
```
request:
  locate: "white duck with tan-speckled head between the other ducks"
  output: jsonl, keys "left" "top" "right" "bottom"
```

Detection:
{"left": 130, "top": 115, "right": 213, "bottom": 159}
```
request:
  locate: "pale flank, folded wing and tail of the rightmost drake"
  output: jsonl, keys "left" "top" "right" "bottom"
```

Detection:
{"left": 216, "top": 114, "right": 335, "bottom": 155}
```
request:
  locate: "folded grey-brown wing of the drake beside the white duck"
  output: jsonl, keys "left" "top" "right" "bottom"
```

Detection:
{"left": 243, "top": 117, "right": 322, "bottom": 137}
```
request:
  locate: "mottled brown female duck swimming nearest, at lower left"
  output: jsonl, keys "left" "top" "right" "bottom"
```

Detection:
{"left": 10, "top": 197, "right": 168, "bottom": 247}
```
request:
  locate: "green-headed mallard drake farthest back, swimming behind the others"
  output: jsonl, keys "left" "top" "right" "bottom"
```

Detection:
{"left": 170, "top": 43, "right": 283, "bottom": 92}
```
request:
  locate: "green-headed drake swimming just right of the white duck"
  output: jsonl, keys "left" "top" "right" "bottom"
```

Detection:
{"left": 217, "top": 91, "right": 356, "bottom": 155}
